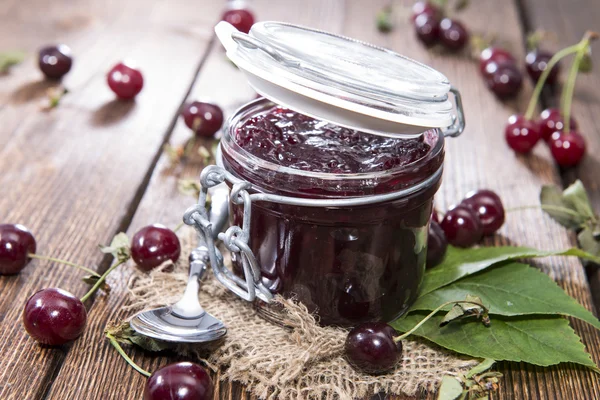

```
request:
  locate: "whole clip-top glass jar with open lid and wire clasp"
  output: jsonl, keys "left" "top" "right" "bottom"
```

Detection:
{"left": 184, "top": 22, "right": 464, "bottom": 326}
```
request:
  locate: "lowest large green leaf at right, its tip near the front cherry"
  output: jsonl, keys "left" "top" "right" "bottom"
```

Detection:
{"left": 391, "top": 312, "right": 600, "bottom": 372}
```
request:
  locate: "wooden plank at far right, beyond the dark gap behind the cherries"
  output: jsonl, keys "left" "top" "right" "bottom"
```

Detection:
{"left": 522, "top": 0, "right": 600, "bottom": 308}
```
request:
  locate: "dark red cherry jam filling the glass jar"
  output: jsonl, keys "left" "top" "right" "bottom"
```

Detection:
{"left": 220, "top": 99, "right": 444, "bottom": 326}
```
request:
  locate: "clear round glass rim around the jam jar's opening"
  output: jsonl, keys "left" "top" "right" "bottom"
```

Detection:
{"left": 221, "top": 98, "right": 444, "bottom": 181}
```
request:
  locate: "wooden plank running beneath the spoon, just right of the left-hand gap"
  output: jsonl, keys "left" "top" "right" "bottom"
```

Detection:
{"left": 47, "top": 0, "right": 343, "bottom": 400}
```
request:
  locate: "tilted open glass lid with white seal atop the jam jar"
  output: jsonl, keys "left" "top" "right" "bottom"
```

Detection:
{"left": 215, "top": 22, "right": 464, "bottom": 137}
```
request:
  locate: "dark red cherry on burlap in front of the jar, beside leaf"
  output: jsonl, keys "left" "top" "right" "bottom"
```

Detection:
{"left": 344, "top": 322, "right": 402, "bottom": 374}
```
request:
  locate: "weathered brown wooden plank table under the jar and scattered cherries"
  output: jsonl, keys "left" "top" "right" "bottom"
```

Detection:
{"left": 0, "top": 0, "right": 600, "bottom": 400}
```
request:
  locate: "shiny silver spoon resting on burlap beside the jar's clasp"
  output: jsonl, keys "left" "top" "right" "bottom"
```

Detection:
{"left": 130, "top": 185, "right": 229, "bottom": 343}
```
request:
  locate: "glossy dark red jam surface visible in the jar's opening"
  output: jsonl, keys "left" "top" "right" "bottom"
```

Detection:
{"left": 235, "top": 106, "right": 431, "bottom": 174}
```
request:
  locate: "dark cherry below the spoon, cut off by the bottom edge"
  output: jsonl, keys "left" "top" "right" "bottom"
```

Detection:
{"left": 144, "top": 362, "right": 213, "bottom": 400}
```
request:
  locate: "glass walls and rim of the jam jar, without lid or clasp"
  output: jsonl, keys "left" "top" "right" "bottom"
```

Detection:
{"left": 219, "top": 99, "right": 444, "bottom": 326}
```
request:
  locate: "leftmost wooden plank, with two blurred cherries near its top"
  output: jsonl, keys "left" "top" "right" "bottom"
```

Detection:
{"left": 0, "top": 0, "right": 211, "bottom": 399}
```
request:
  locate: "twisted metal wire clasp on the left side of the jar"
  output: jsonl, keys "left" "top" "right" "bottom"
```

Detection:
{"left": 183, "top": 165, "right": 273, "bottom": 302}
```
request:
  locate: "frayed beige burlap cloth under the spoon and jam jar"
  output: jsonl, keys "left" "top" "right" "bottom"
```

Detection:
{"left": 127, "top": 227, "right": 477, "bottom": 400}
